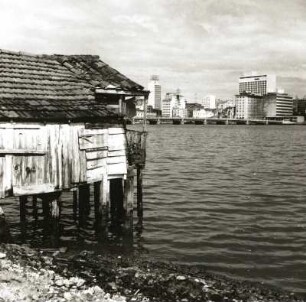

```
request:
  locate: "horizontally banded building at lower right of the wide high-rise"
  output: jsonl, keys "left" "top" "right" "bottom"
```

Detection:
{"left": 263, "top": 92, "right": 293, "bottom": 117}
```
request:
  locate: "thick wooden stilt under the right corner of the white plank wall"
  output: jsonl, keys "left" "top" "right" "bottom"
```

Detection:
{"left": 123, "top": 166, "right": 134, "bottom": 226}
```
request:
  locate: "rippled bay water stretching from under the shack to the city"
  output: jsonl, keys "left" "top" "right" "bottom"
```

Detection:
{"left": 4, "top": 125, "right": 306, "bottom": 293}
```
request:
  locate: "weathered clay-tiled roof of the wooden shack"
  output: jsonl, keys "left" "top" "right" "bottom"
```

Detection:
{"left": 0, "top": 50, "right": 143, "bottom": 120}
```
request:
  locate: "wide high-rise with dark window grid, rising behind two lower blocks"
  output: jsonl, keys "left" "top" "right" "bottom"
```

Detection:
{"left": 239, "top": 73, "right": 276, "bottom": 95}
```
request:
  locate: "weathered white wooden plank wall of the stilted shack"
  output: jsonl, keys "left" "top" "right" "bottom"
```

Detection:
{"left": 0, "top": 124, "right": 127, "bottom": 198}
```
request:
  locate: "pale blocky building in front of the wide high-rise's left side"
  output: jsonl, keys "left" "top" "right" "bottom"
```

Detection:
{"left": 235, "top": 93, "right": 265, "bottom": 119}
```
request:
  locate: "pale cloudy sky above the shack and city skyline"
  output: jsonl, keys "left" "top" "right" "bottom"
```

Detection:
{"left": 0, "top": 0, "right": 306, "bottom": 102}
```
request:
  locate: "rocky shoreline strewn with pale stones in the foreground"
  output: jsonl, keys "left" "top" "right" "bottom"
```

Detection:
{"left": 0, "top": 244, "right": 305, "bottom": 302}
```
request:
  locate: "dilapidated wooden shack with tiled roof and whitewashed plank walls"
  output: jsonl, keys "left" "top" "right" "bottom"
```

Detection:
{"left": 0, "top": 50, "right": 148, "bottom": 229}
